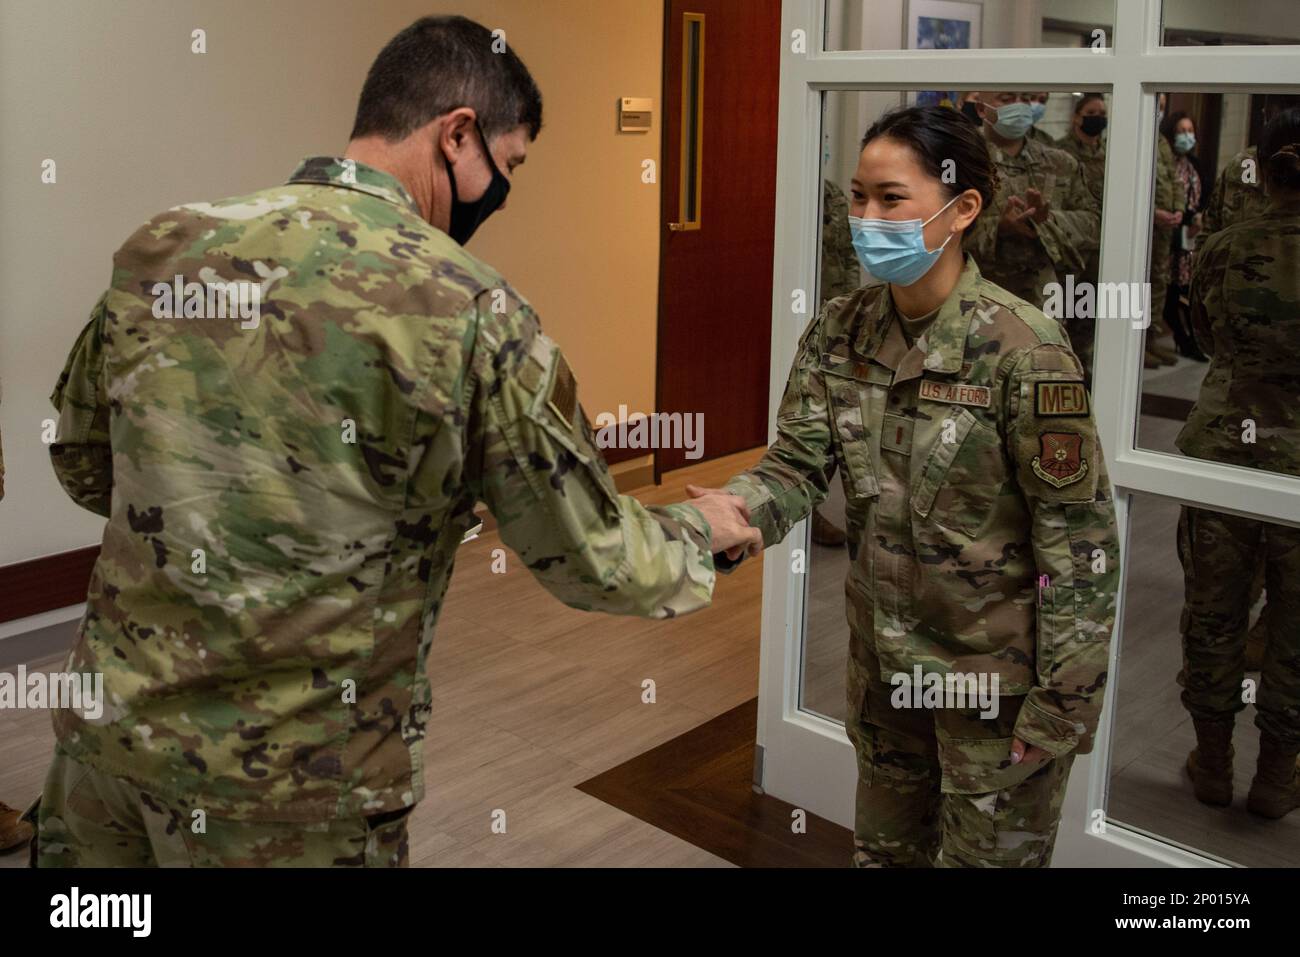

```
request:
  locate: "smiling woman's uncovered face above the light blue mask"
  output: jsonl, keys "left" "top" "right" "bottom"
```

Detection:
{"left": 849, "top": 137, "right": 974, "bottom": 250}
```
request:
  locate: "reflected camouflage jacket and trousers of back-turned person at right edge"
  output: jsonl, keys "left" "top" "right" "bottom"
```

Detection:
{"left": 1178, "top": 202, "right": 1300, "bottom": 745}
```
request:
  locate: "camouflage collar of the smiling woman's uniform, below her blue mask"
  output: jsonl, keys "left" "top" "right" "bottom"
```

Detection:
{"left": 854, "top": 252, "right": 980, "bottom": 382}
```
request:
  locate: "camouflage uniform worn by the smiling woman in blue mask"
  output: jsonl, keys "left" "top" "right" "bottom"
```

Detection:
{"left": 719, "top": 256, "right": 1119, "bottom": 866}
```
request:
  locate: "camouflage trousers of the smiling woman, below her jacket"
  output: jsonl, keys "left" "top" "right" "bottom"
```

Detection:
{"left": 845, "top": 657, "right": 1074, "bottom": 867}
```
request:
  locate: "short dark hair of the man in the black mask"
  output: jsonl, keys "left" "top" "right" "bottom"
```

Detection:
{"left": 352, "top": 17, "right": 542, "bottom": 142}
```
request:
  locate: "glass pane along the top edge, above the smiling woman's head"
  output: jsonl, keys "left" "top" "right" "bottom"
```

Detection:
{"left": 826, "top": 0, "right": 1115, "bottom": 51}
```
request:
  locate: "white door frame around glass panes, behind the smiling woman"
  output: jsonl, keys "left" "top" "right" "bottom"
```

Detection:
{"left": 755, "top": 0, "right": 1300, "bottom": 866}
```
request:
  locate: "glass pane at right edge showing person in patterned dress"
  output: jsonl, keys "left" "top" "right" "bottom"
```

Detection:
{"left": 1136, "top": 91, "right": 1300, "bottom": 475}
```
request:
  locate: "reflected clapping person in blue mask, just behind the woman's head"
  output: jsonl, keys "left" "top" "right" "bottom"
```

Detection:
{"left": 965, "top": 91, "right": 1101, "bottom": 312}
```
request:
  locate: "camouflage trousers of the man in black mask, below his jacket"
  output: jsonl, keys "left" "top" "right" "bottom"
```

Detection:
{"left": 25, "top": 749, "right": 413, "bottom": 867}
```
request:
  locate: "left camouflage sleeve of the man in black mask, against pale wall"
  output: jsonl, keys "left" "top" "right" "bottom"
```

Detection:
{"left": 49, "top": 293, "right": 113, "bottom": 518}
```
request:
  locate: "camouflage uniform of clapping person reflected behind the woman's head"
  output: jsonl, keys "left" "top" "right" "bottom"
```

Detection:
{"left": 965, "top": 131, "right": 1101, "bottom": 308}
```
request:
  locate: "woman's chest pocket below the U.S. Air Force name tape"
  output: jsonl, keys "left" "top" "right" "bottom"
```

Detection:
{"left": 911, "top": 406, "right": 1008, "bottom": 538}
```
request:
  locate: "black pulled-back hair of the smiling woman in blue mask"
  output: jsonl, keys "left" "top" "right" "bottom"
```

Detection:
{"left": 861, "top": 107, "right": 998, "bottom": 229}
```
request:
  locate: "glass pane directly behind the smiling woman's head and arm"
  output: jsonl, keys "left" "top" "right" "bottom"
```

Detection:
{"left": 801, "top": 90, "right": 1108, "bottom": 719}
